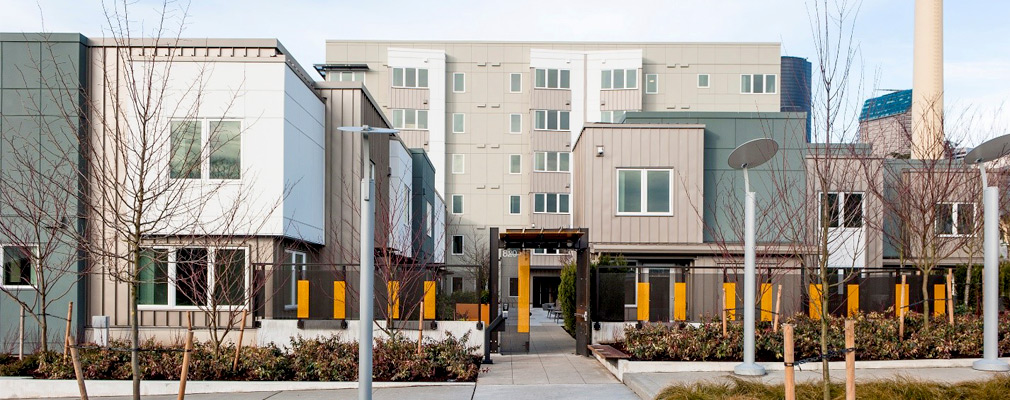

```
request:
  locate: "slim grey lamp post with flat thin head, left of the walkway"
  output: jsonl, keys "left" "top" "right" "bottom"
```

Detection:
{"left": 337, "top": 125, "right": 397, "bottom": 400}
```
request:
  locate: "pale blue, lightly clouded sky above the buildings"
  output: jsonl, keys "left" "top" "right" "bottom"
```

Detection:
{"left": 0, "top": 0, "right": 1010, "bottom": 143}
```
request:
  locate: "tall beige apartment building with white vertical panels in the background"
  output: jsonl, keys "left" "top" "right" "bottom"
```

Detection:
{"left": 316, "top": 40, "right": 810, "bottom": 303}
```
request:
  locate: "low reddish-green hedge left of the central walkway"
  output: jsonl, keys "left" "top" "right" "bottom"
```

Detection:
{"left": 0, "top": 334, "right": 481, "bottom": 382}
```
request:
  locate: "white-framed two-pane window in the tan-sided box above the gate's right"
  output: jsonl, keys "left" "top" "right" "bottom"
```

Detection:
{"left": 617, "top": 169, "right": 673, "bottom": 215}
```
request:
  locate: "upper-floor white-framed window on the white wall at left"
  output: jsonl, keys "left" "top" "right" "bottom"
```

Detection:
{"left": 169, "top": 119, "right": 242, "bottom": 180}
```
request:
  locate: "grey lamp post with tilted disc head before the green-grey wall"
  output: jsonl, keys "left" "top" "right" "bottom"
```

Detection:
{"left": 728, "top": 138, "right": 779, "bottom": 376}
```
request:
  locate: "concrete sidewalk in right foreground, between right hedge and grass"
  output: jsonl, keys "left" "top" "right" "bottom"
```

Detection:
{"left": 624, "top": 365, "right": 1010, "bottom": 400}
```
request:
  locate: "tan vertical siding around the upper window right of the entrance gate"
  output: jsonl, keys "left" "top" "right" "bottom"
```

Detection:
{"left": 573, "top": 124, "right": 704, "bottom": 245}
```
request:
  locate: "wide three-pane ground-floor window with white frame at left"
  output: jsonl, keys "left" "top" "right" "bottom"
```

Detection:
{"left": 137, "top": 247, "right": 248, "bottom": 307}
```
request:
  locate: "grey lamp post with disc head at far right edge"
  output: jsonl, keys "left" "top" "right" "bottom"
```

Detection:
{"left": 965, "top": 134, "right": 1010, "bottom": 371}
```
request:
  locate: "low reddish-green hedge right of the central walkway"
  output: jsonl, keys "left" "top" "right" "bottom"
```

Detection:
{"left": 616, "top": 313, "right": 1010, "bottom": 362}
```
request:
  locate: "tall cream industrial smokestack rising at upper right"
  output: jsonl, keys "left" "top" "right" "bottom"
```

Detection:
{"left": 912, "top": 0, "right": 944, "bottom": 160}
